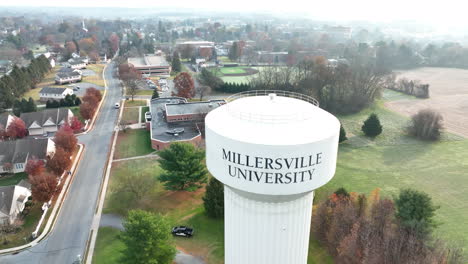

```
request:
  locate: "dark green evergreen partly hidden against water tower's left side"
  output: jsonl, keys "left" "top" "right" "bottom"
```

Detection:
{"left": 203, "top": 177, "right": 224, "bottom": 218}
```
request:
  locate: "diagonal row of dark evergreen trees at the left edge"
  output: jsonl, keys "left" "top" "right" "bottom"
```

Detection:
{"left": 0, "top": 55, "right": 51, "bottom": 108}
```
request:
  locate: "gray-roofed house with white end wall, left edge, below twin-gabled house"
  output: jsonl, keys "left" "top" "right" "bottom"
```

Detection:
{"left": 0, "top": 138, "right": 55, "bottom": 173}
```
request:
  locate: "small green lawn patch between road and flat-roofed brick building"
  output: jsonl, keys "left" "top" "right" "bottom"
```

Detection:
{"left": 114, "top": 129, "right": 154, "bottom": 159}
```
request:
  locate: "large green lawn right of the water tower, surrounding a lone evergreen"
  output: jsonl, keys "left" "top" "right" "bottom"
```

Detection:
{"left": 316, "top": 100, "right": 468, "bottom": 247}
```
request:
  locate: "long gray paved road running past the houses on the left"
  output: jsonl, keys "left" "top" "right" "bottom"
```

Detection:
{"left": 0, "top": 62, "right": 121, "bottom": 264}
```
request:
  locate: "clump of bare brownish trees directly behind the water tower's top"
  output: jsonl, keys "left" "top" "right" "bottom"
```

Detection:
{"left": 250, "top": 57, "right": 384, "bottom": 113}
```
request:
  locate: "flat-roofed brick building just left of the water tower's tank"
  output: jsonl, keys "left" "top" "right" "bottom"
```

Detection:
{"left": 146, "top": 97, "right": 226, "bottom": 150}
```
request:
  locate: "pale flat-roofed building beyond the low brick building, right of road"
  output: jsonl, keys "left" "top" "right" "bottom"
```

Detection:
{"left": 128, "top": 55, "right": 171, "bottom": 77}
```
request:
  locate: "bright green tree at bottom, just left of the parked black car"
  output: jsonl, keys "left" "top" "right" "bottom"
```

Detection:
{"left": 120, "top": 210, "right": 176, "bottom": 264}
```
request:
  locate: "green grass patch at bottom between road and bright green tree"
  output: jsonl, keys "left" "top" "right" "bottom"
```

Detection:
{"left": 93, "top": 227, "right": 125, "bottom": 264}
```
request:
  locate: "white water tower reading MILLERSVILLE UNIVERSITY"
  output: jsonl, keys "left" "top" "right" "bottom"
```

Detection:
{"left": 205, "top": 91, "right": 340, "bottom": 264}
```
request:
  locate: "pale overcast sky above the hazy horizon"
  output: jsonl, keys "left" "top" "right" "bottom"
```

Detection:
{"left": 0, "top": 0, "right": 468, "bottom": 26}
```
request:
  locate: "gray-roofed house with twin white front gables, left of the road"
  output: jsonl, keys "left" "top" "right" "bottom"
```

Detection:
{"left": 20, "top": 108, "right": 73, "bottom": 136}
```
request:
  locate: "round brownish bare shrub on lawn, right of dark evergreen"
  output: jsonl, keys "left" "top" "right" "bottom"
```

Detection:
{"left": 408, "top": 109, "right": 443, "bottom": 140}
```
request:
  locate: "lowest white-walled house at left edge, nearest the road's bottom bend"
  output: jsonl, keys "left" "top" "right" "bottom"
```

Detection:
{"left": 0, "top": 180, "right": 31, "bottom": 225}
